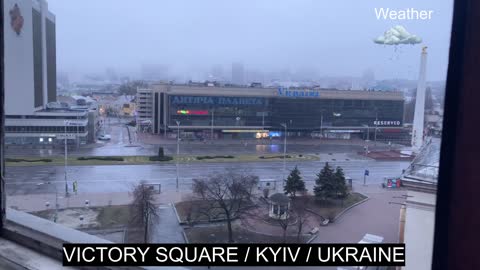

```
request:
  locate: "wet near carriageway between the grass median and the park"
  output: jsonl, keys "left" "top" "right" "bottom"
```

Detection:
{"left": 6, "top": 160, "right": 409, "bottom": 195}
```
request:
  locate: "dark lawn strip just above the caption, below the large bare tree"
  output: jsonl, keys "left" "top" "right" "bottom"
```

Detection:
{"left": 185, "top": 225, "right": 309, "bottom": 243}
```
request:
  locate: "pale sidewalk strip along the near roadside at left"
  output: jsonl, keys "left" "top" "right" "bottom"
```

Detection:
{"left": 7, "top": 191, "right": 188, "bottom": 212}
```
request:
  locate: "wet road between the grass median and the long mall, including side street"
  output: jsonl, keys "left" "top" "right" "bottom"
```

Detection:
{"left": 6, "top": 118, "right": 402, "bottom": 157}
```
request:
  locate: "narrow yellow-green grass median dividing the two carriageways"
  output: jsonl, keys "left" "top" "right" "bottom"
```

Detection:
{"left": 5, "top": 155, "right": 318, "bottom": 166}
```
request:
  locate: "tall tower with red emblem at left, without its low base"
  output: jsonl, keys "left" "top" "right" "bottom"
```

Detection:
{"left": 3, "top": 0, "right": 57, "bottom": 115}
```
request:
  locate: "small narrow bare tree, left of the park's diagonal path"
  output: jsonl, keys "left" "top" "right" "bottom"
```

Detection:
{"left": 131, "top": 181, "right": 158, "bottom": 243}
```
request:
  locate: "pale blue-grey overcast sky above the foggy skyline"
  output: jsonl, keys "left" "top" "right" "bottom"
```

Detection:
{"left": 48, "top": 0, "right": 452, "bottom": 80}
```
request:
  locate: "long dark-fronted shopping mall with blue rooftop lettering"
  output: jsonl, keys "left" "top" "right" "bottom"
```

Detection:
{"left": 137, "top": 84, "right": 409, "bottom": 142}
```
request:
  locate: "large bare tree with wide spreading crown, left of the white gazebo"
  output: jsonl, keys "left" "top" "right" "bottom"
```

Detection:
{"left": 193, "top": 171, "right": 258, "bottom": 243}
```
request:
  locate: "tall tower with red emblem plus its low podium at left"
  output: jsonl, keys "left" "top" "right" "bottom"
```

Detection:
{"left": 3, "top": 0, "right": 93, "bottom": 145}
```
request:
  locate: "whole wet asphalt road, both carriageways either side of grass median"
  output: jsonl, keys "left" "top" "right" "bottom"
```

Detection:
{"left": 6, "top": 119, "right": 409, "bottom": 195}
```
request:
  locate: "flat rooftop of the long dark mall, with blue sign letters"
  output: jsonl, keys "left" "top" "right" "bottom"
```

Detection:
{"left": 139, "top": 83, "right": 404, "bottom": 101}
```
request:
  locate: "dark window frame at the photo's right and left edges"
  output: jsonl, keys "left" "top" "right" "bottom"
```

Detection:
{"left": 0, "top": 0, "right": 480, "bottom": 269}
